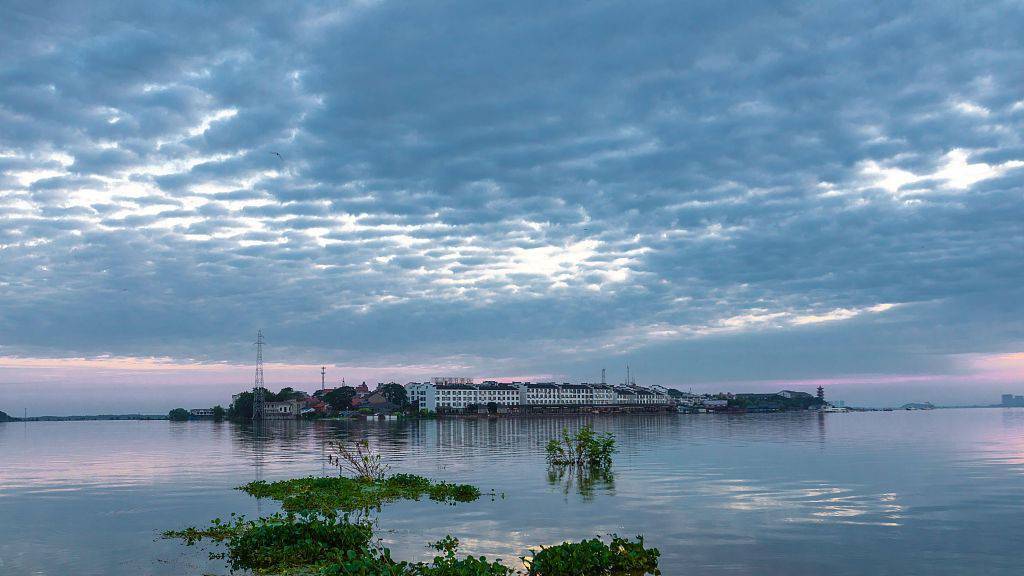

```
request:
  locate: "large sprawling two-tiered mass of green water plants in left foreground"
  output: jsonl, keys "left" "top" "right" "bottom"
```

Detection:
{"left": 164, "top": 474, "right": 503, "bottom": 576}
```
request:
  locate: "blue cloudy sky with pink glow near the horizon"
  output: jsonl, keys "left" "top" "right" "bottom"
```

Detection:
{"left": 0, "top": 0, "right": 1024, "bottom": 414}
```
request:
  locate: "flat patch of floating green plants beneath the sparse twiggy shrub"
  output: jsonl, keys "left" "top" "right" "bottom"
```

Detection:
{"left": 239, "top": 474, "right": 480, "bottom": 517}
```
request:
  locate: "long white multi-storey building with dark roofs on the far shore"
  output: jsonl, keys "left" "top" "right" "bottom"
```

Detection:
{"left": 406, "top": 378, "right": 670, "bottom": 411}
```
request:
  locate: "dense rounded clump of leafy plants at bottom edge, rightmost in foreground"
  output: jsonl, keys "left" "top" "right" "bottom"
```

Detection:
{"left": 522, "top": 534, "right": 662, "bottom": 576}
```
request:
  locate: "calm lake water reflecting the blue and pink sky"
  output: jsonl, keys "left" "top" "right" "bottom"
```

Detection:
{"left": 0, "top": 409, "right": 1024, "bottom": 576}
